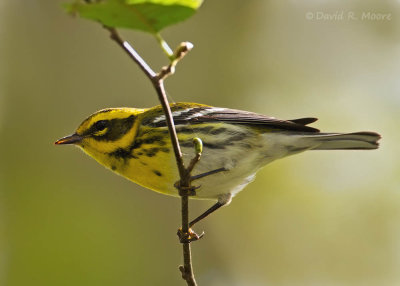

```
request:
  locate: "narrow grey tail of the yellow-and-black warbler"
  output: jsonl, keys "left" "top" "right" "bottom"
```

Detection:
{"left": 303, "top": 131, "right": 381, "bottom": 150}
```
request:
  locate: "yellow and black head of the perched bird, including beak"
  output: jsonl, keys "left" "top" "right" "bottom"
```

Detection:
{"left": 55, "top": 108, "right": 143, "bottom": 156}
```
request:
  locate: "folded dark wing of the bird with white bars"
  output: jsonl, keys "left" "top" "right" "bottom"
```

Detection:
{"left": 146, "top": 105, "right": 319, "bottom": 132}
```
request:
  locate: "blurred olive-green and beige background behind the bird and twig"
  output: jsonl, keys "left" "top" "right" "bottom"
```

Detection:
{"left": 0, "top": 0, "right": 400, "bottom": 286}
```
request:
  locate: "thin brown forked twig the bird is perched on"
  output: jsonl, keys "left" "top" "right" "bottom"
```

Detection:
{"left": 104, "top": 26, "right": 201, "bottom": 286}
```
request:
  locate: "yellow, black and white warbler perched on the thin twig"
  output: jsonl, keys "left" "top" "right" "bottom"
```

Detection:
{"left": 56, "top": 103, "right": 380, "bottom": 223}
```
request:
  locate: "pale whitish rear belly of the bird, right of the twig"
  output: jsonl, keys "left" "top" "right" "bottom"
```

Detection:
{"left": 175, "top": 133, "right": 308, "bottom": 199}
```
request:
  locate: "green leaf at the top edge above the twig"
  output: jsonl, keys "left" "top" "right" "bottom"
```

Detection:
{"left": 64, "top": 0, "right": 203, "bottom": 34}
